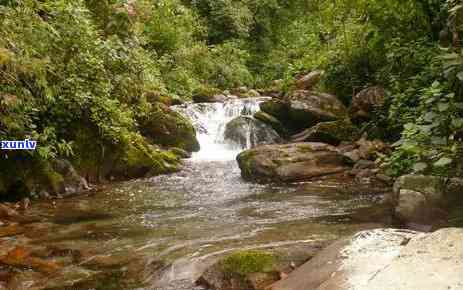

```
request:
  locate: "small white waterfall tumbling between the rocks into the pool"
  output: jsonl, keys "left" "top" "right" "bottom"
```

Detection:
{"left": 174, "top": 98, "right": 268, "bottom": 160}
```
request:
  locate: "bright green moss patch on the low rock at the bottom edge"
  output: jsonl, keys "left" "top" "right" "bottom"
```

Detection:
{"left": 220, "top": 251, "right": 275, "bottom": 277}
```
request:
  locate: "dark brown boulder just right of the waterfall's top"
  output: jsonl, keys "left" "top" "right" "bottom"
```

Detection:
{"left": 260, "top": 90, "right": 347, "bottom": 131}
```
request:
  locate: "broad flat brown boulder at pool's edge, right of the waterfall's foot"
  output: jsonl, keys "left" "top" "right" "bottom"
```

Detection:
{"left": 237, "top": 143, "right": 352, "bottom": 182}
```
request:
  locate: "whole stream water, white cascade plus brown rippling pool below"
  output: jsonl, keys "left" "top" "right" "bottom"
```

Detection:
{"left": 20, "top": 100, "right": 387, "bottom": 290}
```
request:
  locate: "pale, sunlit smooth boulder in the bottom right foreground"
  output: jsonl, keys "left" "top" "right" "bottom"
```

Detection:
{"left": 268, "top": 228, "right": 463, "bottom": 290}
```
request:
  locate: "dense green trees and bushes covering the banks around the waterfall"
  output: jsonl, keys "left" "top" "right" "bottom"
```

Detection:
{"left": 0, "top": 0, "right": 463, "bottom": 197}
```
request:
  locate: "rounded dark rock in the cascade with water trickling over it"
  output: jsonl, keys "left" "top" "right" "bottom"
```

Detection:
{"left": 224, "top": 116, "right": 280, "bottom": 148}
